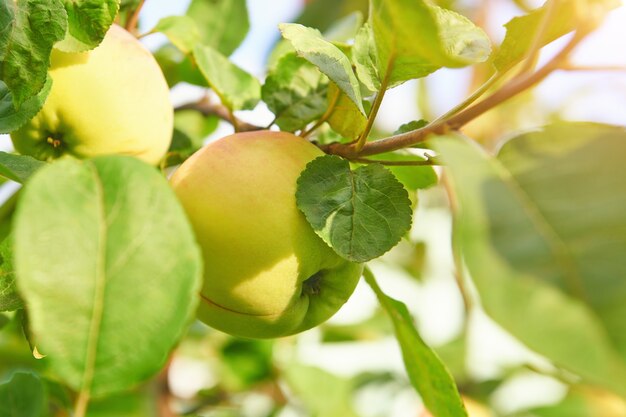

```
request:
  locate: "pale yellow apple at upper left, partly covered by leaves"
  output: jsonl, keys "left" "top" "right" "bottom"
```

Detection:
{"left": 11, "top": 25, "right": 174, "bottom": 164}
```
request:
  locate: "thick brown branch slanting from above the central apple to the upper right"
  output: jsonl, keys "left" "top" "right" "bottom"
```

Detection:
{"left": 321, "top": 31, "right": 587, "bottom": 159}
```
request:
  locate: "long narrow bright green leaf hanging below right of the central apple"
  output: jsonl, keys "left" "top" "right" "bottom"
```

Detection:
{"left": 363, "top": 268, "right": 467, "bottom": 417}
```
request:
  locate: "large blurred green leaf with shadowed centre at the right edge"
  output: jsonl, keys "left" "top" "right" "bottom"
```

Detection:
{"left": 432, "top": 127, "right": 626, "bottom": 395}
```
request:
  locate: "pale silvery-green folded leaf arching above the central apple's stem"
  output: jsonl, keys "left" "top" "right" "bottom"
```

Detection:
{"left": 278, "top": 23, "right": 365, "bottom": 114}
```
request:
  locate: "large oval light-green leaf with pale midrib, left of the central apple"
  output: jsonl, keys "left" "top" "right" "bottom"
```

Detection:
{"left": 13, "top": 156, "right": 202, "bottom": 397}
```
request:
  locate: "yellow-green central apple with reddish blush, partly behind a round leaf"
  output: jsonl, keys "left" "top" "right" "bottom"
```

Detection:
{"left": 171, "top": 131, "right": 363, "bottom": 338}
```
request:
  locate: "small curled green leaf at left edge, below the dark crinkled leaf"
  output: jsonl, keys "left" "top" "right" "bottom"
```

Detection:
{"left": 0, "top": 78, "right": 52, "bottom": 134}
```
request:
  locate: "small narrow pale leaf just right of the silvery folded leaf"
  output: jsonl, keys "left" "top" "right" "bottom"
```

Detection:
{"left": 352, "top": 24, "right": 381, "bottom": 94}
